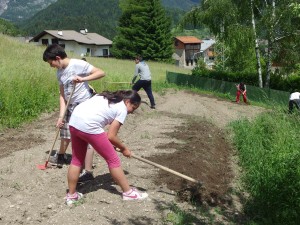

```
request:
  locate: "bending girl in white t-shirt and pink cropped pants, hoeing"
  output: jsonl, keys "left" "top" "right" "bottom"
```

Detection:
{"left": 66, "top": 90, "right": 148, "bottom": 206}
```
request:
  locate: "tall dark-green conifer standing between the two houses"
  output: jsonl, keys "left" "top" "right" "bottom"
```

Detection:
{"left": 112, "top": 0, "right": 173, "bottom": 61}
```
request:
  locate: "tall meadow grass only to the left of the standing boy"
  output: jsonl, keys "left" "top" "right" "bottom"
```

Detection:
{"left": 0, "top": 35, "right": 58, "bottom": 129}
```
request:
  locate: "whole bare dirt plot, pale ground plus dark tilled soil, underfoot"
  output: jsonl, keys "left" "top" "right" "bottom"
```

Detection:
{"left": 0, "top": 91, "right": 263, "bottom": 225}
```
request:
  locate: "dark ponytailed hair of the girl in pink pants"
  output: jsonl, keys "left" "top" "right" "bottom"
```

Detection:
{"left": 98, "top": 90, "right": 142, "bottom": 105}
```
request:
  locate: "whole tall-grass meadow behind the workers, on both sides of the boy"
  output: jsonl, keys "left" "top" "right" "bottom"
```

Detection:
{"left": 0, "top": 35, "right": 190, "bottom": 130}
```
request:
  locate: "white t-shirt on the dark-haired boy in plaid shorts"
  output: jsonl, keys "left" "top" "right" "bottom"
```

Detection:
{"left": 57, "top": 59, "right": 94, "bottom": 104}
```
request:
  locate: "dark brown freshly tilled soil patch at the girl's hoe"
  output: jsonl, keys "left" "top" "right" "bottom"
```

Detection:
{"left": 148, "top": 119, "right": 233, "bottom": 206}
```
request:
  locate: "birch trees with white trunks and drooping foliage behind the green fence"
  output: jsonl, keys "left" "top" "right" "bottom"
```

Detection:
{"left": 180, "top": 0, "right": 300, "bottom": 87}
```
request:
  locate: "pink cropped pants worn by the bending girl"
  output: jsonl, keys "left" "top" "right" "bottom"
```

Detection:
{"left": 70, "top": 126, "right": 121, "bottom": 168}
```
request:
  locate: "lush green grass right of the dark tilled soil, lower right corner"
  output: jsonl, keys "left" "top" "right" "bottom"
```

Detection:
{"left": 232, "top": 111, "right": 300, "bottom": 224}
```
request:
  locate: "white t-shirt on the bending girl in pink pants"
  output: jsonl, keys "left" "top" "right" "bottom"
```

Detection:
{"left": 69, "top": 95, "right": 127, "bottom": 134}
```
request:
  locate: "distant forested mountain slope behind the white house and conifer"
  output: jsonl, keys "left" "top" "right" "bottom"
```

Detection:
{"left": 18, "top": 0, "right": 199, "bottom": 39}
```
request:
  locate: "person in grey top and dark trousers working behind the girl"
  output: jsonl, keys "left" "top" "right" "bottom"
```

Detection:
{"left": 131, "top": 55, "right": 155, "bottom": 109}
